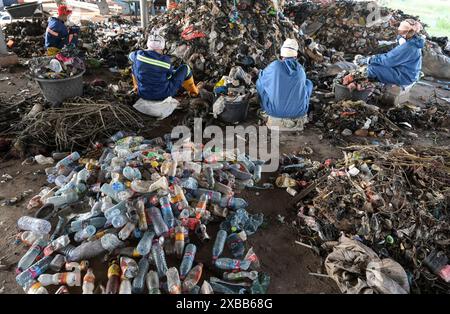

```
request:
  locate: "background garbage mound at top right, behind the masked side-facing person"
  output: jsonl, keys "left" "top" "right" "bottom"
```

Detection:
{"left": 285, "top": 0, "right": 417, "bottom": 55}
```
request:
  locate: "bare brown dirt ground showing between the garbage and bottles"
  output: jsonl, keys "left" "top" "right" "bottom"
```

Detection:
{"left": 0, "top": 64, "right": 450, "bottom": 293}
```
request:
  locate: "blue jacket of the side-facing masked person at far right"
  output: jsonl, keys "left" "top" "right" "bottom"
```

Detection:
{"left": 368, "top": 35, "right": 425, "bottom": 86}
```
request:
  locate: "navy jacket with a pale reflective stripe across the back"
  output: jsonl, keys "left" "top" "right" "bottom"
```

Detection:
{"left": 128, "top": 50, "right": 181, "bottom": 100}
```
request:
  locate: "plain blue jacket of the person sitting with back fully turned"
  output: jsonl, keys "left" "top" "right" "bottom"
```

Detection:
{"left": 256, "top": 58, "right": 313, "bottom": 118}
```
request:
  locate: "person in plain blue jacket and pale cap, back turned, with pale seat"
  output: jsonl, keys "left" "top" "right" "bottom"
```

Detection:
{"left": 256, "top": 38, "right": 313, "bottom": 131}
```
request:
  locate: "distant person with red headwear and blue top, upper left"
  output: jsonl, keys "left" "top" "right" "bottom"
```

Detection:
{"left": 45, "top": 5, "right": 79, "bottom": 56}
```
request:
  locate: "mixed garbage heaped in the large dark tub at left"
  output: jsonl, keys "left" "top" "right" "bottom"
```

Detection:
{"left": 29, "top": 47, "right": 86, "bottom": 79}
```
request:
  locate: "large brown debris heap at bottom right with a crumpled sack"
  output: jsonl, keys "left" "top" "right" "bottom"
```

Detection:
{"left": 297, "top": 146, "right": 450, "bottom": 293}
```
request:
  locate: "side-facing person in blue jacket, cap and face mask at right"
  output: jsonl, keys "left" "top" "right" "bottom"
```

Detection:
{"left": 356, "top": 19, "right": 425, "bottom": 87}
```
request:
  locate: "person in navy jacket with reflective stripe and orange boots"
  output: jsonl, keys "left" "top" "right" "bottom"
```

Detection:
{"left": 128, "top": 34, "right": 199, "bottom": 100}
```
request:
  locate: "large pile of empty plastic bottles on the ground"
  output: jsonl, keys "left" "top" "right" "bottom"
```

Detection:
{"left": 16, "top": 132, "right": 270, "bottom": 294}
